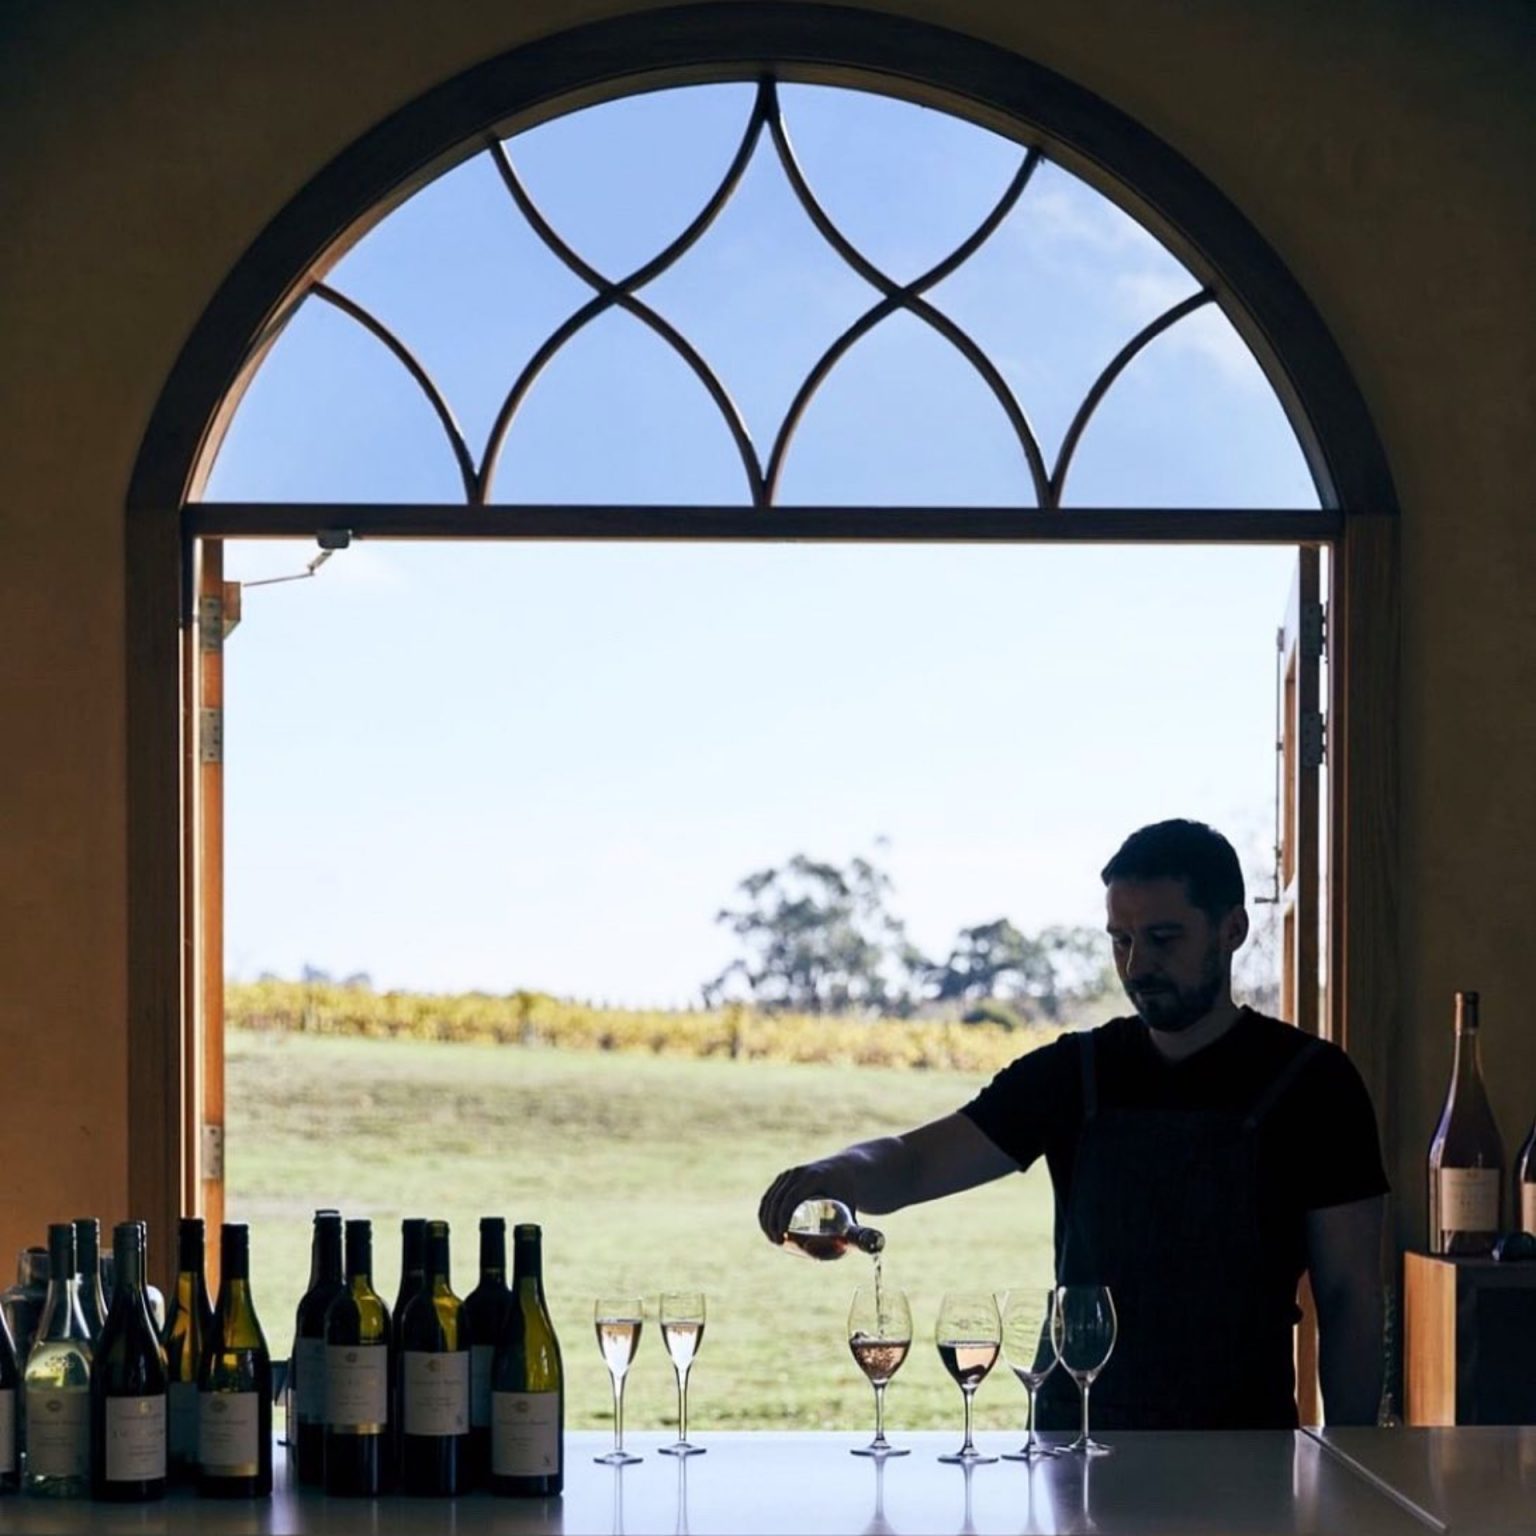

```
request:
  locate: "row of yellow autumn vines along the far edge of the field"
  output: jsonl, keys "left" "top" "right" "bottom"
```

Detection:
{"left": 224, "top": 969, "right": 1061, "bottom": 1072}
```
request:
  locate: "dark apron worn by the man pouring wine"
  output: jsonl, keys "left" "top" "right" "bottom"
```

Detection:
{"left": 1037, "top": 1034, "right": 1318, "bottom": 1430}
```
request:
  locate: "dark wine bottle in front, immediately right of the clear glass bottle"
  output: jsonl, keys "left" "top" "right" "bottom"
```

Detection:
{"left": 91, "top": 1221, "right": 170, "bottom": 1504}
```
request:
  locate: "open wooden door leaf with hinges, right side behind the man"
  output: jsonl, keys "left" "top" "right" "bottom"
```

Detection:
{"left": 1275, "top": 545, "right": 1327, "bottom": 1424}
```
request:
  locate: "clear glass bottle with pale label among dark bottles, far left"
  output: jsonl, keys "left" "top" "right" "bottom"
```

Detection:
{"left": 25, "top": 1221, "right": 92, "bottom": 1499}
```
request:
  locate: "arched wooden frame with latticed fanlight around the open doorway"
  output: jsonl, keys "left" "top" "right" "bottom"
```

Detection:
{"left": 126, "top": 5, "right": 1395, "bottom": 1333}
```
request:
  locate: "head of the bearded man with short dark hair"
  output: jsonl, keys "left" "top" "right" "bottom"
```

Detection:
{"left": 1101, "top": 820, "right": 1249, "bottom": 1032}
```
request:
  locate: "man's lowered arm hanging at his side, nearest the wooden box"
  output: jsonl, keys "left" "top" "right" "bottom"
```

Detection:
{"left": 1307, "top": 1195, "right": 1387, "bottom": 1425}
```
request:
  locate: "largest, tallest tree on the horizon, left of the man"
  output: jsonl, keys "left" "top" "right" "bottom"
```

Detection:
{"left": 703, "top": 854, "right": 928, "bottom": 1014}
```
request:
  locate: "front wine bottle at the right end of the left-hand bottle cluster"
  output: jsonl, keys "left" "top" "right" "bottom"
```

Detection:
{"left": 197, "top": 1223, "right": 272, "bottom": 1499}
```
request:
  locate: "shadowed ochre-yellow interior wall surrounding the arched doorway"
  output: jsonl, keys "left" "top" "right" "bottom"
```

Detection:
{"left": 0, "top": 0, "right": 1536, "bottom": 1267}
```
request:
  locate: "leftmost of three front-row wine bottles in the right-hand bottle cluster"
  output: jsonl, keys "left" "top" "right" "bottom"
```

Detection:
{"left": 324, "top": 1221, "right": 390, "bottom": 1498}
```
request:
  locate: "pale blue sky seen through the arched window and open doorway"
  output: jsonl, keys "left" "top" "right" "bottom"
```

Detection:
{"left": 207, "top": 86, "right": 1316, "bottom": 1005}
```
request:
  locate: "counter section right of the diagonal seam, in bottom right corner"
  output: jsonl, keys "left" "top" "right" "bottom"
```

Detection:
{"left": 1309, "top": 1425, "right": 1536, "bottom": 1536}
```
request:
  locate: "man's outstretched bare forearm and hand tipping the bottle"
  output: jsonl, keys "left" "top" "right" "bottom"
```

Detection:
{"left": 757, "top": 1114, "right": 1018, "bottom": 1243}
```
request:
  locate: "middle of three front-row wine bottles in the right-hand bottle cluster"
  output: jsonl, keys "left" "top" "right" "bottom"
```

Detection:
{"left": 396, "top": 1221, "right": 470, "bottom": 1496}
